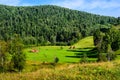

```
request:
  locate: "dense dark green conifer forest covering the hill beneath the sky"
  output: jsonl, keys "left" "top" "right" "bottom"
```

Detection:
{"left": 0, "top": 5, "right": 118, "bottom": 45}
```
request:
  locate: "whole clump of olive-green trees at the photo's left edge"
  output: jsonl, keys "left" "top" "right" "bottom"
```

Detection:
{"left": 0, "top": 36, "right": 26, "bottom": 72}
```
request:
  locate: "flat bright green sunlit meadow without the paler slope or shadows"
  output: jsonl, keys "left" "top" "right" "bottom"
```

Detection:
{"left": 26, "top": 46, "right": 79, "bottom": 62}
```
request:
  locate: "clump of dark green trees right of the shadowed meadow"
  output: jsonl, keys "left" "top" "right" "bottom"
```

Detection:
{"left": 94, "top": 27, "right": 120, "bottom": 61}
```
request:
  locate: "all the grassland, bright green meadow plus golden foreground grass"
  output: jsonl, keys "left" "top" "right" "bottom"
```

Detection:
{"left": 0, "top": 36, "right": 120, "bottom": 80}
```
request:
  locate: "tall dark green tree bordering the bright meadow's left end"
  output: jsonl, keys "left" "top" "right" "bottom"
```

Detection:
{"left": 9, "top": 35, "right": 26, "bottom": 71}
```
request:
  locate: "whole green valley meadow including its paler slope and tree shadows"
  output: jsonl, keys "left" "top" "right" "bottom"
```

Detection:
{"left": 24, "top": 36, "right": 96, "bottom": 63}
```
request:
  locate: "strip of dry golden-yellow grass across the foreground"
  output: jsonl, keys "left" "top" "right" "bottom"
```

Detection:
{"left": 0, "top": 61, "right": 120, "bottom": 80}
